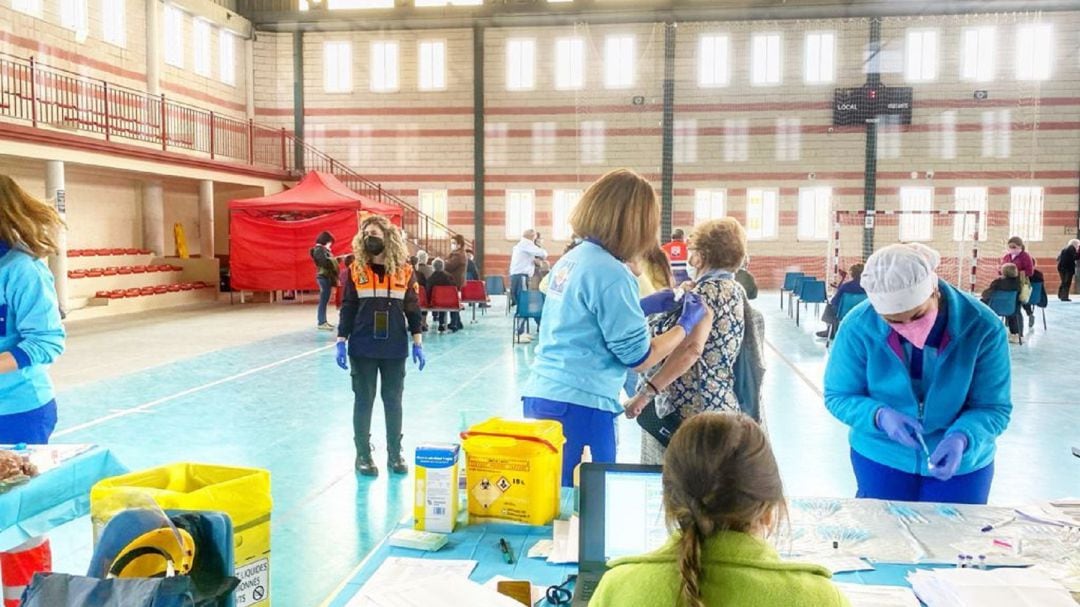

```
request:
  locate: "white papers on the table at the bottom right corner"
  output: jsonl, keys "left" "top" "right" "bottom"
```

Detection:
{"left": 907, "top": 568, "right": 1076, "bottom": 607}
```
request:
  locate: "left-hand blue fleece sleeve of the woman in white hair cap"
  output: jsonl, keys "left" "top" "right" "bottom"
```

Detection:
{"left": 825, "top": 319, "right": 885, "bottom": 433}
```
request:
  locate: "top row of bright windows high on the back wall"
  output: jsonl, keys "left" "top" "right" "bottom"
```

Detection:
{"left": 317, "top": 21, "right": 1053, "bottom": 93}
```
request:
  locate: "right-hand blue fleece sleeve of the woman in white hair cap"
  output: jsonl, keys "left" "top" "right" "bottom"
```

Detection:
{"left": 946, "top": 322, "right": 1012, "bottom": 448}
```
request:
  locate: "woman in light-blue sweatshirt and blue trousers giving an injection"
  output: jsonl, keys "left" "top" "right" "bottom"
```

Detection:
{"left": 522, "top": 168, "right": 708, "bottom": 486}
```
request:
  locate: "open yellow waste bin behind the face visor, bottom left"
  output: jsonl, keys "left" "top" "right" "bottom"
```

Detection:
{"left": 90, "top": 462, "right": 273, "bottom": 607}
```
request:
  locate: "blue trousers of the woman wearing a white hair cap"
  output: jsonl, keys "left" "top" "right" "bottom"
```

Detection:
{"left": 851, "top": 449, "right": 994, "bottom": 504}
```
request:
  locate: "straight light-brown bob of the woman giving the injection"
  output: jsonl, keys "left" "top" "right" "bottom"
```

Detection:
{"left": 570, "top": 168, "right": 660, "bottom": 260}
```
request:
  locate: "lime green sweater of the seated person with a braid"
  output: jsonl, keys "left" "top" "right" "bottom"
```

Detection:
{"left": 589, "top": 531, "right": 848, "bottom": 607}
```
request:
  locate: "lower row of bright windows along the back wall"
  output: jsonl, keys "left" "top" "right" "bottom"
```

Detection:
{"left": 419, "top": 186, "right": 1043, "bottom": 242}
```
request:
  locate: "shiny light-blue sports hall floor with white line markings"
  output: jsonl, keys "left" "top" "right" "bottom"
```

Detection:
{"left": 46, "top": 293, "right": 1080, "bottom": 607}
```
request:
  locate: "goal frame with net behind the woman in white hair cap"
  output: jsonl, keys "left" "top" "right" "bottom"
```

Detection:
{"left": 826, "top": 210, "right": 986, "bottom": 293}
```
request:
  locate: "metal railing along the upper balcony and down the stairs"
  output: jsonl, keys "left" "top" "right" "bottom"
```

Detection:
{"left": 0, "top": 53, "right": 457, "bottom": 256}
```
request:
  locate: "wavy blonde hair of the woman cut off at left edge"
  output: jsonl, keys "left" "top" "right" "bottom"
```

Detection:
{"left": 0, "top": 175, "right": 64, "bottom": 257}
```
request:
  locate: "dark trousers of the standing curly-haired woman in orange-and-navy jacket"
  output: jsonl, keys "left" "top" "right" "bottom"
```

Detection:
{"left": 349, "top": 356, "right": 408, "bottom": 456}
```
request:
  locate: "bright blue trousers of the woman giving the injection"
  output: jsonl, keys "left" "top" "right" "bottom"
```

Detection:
{"left": 522, "top": 396, "right": 621, "bottom": 487}
